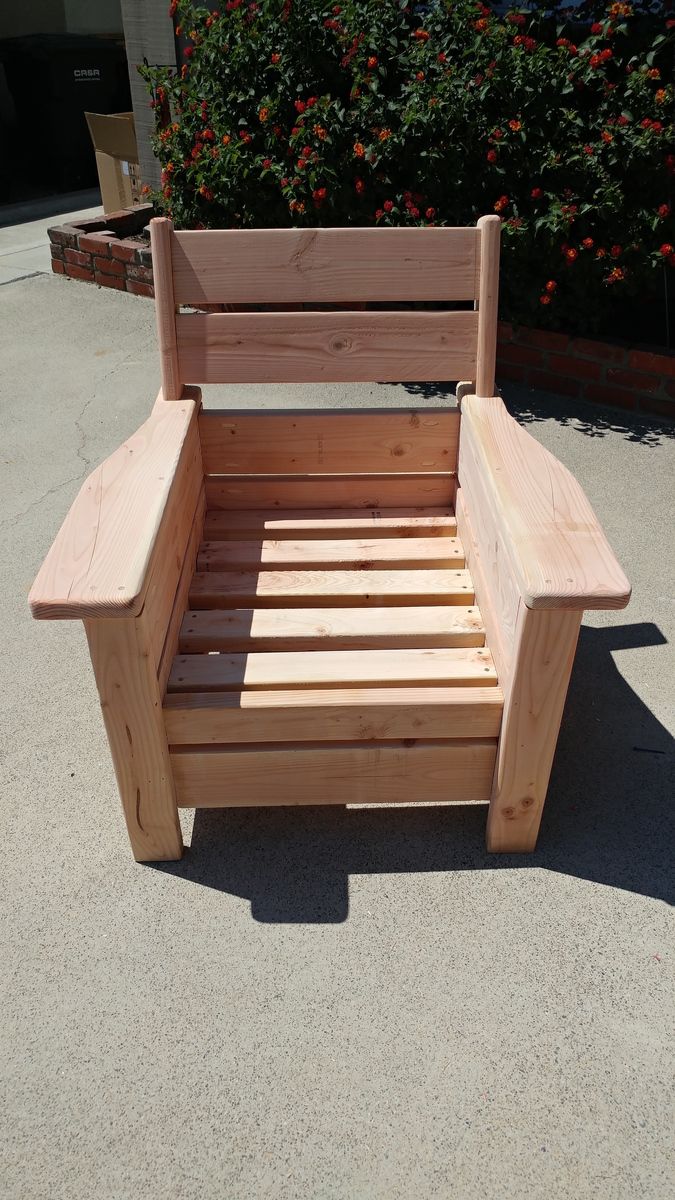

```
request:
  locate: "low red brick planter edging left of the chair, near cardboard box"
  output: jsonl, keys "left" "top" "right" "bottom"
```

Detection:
{"left": 49, "top": 204, "right": 155, "bottom": 296}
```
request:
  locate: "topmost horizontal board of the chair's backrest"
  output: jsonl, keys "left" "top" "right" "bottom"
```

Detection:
{"left": 172, "top": 228, "right": 480, "bottom": 305}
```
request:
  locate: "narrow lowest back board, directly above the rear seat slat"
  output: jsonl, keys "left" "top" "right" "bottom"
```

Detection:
{"left": 205, "top": 473, "right": 456, "bottom": 511}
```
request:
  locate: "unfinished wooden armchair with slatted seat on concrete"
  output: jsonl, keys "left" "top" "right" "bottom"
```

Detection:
{"left": 30, "top": 217, "right": 631, "bottom": 860}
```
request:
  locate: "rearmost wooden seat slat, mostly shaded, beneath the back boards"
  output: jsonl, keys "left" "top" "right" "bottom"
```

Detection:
{"left": 204, "top": 508, "right": 456, "bottom": 541}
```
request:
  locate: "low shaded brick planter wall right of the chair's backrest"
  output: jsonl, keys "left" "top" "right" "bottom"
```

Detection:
{"left": 497, "top": 324, "right": 675, "bottom": 418}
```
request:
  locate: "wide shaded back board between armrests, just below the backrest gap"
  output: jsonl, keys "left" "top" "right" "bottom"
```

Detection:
{"left": 199, "top": 408, "right": 459, "bottom": 475}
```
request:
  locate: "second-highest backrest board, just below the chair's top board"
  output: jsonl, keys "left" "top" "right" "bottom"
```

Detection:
{"left": 177, "top": 311, "right": 478, "bottom": 383}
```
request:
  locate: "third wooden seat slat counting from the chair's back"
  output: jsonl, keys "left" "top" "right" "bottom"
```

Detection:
{"left": 189, "top": 569, "right": 474, "bottom": 608}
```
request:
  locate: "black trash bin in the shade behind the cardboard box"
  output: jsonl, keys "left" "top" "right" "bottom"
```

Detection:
{"left": 0, "top": 34, "right": 131, "bottom": 199}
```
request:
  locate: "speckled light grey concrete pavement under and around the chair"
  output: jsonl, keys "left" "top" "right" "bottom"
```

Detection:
{"left": 0, "top": 265, "right": 675, "bottom": 1200}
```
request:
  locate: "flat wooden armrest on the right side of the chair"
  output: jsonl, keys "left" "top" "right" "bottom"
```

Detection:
{"left": 459, "top": 396, "right": 631, "bottom": 610}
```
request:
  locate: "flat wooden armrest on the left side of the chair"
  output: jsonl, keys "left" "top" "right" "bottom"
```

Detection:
{"left": 29, "top": 389, "right": 201, "bottom": 620}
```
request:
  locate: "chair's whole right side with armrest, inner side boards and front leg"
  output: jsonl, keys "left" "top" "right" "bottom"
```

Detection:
{"left": 456, "top": 394, "right": 631, "bottom": 852}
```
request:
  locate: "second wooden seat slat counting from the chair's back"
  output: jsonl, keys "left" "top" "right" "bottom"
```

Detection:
{"left": 197, "top": 538, "right": 464, "bottom": 571}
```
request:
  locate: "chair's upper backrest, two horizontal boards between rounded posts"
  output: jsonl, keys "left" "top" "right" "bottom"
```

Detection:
{"left": 150, "top": 216, "right": 501, "bottom": 400}
